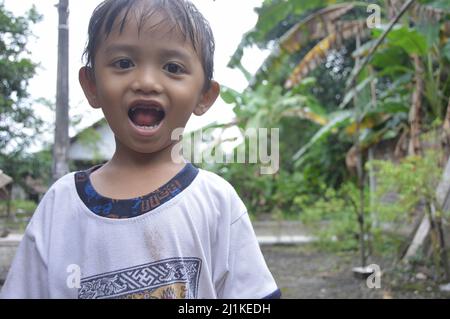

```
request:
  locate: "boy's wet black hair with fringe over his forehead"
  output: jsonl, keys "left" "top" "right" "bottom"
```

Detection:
{"left": 83, "top": 0, "right": 215, "bottom": 90}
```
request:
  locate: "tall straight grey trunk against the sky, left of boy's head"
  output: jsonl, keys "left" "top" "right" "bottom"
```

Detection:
{"left": 52, "top": 0, "right": 69, "bottom": 181}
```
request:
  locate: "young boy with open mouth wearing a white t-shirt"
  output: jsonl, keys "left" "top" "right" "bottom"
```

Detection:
{"left": 2, "top": 0, "right": 280, "bottom": 298}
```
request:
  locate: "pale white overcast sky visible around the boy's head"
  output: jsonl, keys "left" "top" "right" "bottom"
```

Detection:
{"left": 4, "top": 0, "right": 266, "bottom": 144}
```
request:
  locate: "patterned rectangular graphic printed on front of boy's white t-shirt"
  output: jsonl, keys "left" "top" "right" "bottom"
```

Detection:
{"left": 78, "top": 258, "right": 201, "bottom": 299}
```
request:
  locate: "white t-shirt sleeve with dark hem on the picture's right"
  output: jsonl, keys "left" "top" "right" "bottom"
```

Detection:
{"left": 218, "top": 213, "right": 278, "bottom": 299}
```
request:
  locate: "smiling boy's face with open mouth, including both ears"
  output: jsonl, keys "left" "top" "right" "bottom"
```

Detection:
{"left": 80, "top": 8, "right": 219, "bottom": 153}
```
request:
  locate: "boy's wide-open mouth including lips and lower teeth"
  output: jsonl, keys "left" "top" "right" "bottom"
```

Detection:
{"left": 128, "top": 100, "right": 166, "bottom": 136}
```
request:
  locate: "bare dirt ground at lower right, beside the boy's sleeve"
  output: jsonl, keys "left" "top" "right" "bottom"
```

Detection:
{"left": 262, "top": 244, "right": 450, "bottom": 299}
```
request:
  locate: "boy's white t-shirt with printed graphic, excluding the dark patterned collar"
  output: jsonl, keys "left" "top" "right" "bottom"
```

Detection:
{"left": 1, "top": 164, "right": 279, "bottom": 299}
